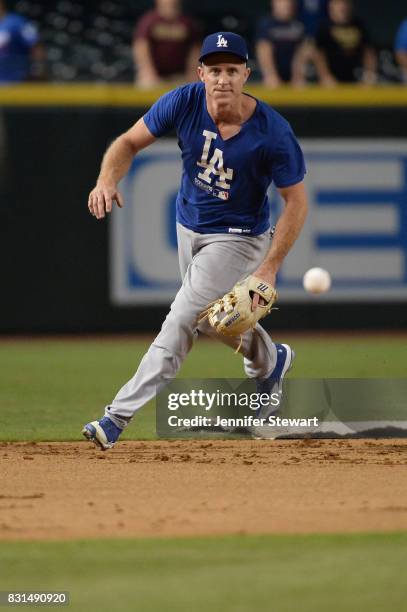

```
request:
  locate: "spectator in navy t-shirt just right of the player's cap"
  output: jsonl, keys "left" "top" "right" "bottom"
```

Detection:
{"left": 256, "top": 0, "right": 305, "bottom": 88}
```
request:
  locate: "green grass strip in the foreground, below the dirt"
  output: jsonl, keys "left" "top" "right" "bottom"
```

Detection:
{"left": 0, "top": 534, "right": 407, "bottom": 612}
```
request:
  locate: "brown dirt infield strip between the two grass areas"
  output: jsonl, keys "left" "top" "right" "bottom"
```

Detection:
{"left": 0, "top": 440, "right": 407, "bottom": 540}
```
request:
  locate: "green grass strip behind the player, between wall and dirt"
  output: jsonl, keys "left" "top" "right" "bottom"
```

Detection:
{"left": 0, "top": 336, "right": 407, "bottom": 440}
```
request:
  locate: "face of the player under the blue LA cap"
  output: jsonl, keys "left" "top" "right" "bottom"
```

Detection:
{"left": 198, "top": 53, "right": 250, "bottom": 103}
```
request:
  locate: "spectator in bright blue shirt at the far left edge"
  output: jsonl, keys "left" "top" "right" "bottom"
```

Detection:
{"left": 0, "top": 0, "right": 44, "bottom": 84}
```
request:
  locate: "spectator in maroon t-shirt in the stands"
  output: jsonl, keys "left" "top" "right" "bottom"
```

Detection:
{"left": 133, "top": 0, "right": 201, "bottom": 87}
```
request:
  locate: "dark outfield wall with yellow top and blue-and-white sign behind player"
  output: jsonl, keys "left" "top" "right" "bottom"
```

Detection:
{"left": 0, "top": 86, "right": 407, "bottom": 333}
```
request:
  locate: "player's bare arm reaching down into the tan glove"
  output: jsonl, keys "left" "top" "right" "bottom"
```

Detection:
{"left": 253, "top": 181, "right": 308, "bottom": 308}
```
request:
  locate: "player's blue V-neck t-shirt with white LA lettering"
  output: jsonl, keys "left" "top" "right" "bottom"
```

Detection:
{"left": 144, "top": 83, "right": 305, "bottom": 236}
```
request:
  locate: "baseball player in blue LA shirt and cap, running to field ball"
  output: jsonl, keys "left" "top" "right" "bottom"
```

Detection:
{"left": 82, "top": 32, "right": 307, "bottom": 450}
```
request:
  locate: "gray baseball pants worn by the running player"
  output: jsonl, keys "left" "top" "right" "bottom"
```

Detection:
{"left": 105, "top": 224, "right": 277, "bottom": 428}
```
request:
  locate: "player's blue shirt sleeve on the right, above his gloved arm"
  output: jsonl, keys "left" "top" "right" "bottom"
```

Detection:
{"left": 272, "top": 124, "right": 306, "bottom": 188}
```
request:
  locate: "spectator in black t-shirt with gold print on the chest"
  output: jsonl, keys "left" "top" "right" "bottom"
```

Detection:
{"left": 315, "top": 0, "right": 377, "bottom": 86}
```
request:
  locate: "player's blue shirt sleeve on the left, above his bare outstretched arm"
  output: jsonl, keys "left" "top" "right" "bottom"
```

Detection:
{"left": 143, "top": 87, "right": 187, "bottom": 138}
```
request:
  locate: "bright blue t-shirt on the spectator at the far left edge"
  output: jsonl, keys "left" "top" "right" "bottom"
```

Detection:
{"left": 0, "top": 13, "right": 38, "bottom": 83}
